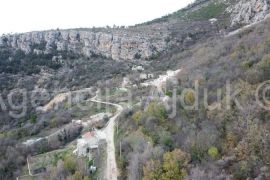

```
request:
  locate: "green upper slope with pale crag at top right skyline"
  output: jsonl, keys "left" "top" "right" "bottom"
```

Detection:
{"left": 146, "top": 0, "right": 270, "bottom": 31}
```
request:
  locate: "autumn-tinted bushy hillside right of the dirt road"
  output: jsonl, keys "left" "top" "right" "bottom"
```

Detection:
{"left": 116, "top": 17, "right": 270, "bottom": 179}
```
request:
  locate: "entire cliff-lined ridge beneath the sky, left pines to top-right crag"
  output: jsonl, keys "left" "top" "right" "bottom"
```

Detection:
{"left": 0, "top": 0, "right": 269, "bottom": 73}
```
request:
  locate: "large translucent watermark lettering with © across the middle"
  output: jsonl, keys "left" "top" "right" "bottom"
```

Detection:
{"left": 0, "top": 80, "right": 270, "bottom": 119}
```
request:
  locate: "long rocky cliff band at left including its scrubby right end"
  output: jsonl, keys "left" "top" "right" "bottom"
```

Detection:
{"left": 0, "top": 20, "right": 217, "bottom": 60}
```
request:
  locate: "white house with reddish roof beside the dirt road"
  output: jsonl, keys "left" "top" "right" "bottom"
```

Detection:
{"left": 74, "top": 131, "right": 99, "bottom": 158}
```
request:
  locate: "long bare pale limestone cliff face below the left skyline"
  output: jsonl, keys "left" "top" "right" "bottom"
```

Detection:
{"left": 0, "top": 29, "right": 171, "bottom": 60}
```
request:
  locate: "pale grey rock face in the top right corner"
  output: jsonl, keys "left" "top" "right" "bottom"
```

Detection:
{"left": 227, "top": 0, "right": 270, "bottom": 26}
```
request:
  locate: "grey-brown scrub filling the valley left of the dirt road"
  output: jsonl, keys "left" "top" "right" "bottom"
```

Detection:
{"left": 0, "top": 53, "right": 129, "bottom": 179}
